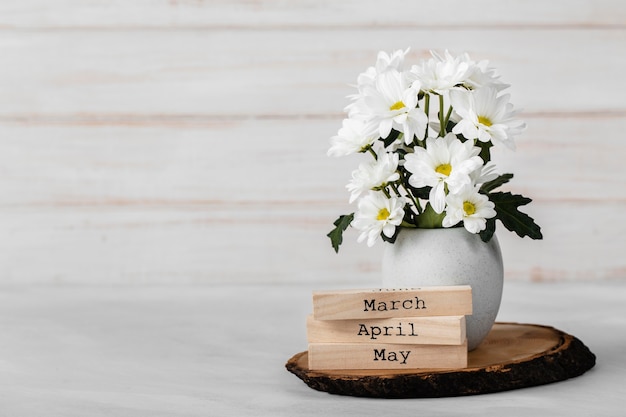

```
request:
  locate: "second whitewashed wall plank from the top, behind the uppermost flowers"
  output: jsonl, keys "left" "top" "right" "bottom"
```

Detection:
{"left": 0, "top": 28, "right": 626, "bottom": 115}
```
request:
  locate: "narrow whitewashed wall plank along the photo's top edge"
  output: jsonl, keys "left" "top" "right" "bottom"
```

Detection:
{"left": 0, "top": 0, "right": 626, "bottom": 30}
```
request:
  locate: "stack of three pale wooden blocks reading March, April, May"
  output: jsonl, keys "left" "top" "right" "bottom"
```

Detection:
{"left": 307, "top": 285, "right": 472, "bottom": 370}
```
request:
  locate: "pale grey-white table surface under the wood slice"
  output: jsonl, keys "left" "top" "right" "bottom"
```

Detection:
{"left": 0, "top": 282, "right": 626, "bottom": 417}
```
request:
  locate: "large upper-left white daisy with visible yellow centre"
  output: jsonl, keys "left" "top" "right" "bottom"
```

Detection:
{"left": 363, "top": 70, "right": 428, "bottom": 145}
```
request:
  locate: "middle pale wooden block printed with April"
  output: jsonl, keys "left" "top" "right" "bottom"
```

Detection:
{"left": 307, "top": 315, "right": 465, "bottom": 345}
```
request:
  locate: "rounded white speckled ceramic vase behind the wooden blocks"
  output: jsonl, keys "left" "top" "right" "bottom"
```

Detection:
{"left": 382, "top": 227, "right": 504, "bottom": 350}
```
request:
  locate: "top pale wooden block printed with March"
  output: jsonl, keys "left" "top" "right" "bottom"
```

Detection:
{"left": 313, "top": 285, "right": 472, "bottom": 320}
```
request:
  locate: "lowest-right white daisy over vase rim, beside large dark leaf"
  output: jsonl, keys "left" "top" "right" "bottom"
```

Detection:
{"left": 442, "top": 184, "right": 496, "bottom": 233}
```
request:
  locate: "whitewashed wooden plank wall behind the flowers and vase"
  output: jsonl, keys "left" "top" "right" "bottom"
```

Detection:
{"left": 0, "top": 0, "right": 626, "bottom": 286}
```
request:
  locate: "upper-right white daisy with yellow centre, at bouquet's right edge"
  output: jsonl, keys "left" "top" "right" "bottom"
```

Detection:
{"left": 450, "top": 87, "right": 526, "bottom": 149}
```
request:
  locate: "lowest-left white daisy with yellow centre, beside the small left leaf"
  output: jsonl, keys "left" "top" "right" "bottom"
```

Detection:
{"left": 351, "top": 191, "right": 405, "bottom": 247}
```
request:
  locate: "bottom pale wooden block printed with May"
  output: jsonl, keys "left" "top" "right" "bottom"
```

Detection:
{"left": 309, "top": 341, "right": 467, "bottom": 370}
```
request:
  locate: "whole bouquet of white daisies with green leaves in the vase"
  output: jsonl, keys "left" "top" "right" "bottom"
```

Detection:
{"left": 328, "top": 50, "right": 542, "bottom": 251}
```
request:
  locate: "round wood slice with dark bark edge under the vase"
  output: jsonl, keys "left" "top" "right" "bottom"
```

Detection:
{"left": 286, "top": 323, "right": 596, "bottom": 398}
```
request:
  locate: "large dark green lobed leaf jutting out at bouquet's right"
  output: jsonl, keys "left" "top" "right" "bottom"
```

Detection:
{"left": 488, "top": 192, "right": 543, "bottom": 239}
